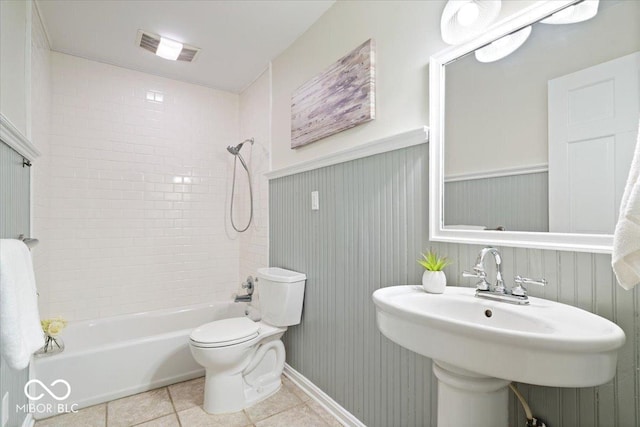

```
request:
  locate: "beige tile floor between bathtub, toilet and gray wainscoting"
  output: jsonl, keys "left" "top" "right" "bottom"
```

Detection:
{"left": 35, "top": 376, "right": 341, "bottom": 427}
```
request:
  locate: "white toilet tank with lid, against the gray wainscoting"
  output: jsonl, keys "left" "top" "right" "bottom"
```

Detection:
{"left": 258, "top": 267, "right": 307, "bottom": 326}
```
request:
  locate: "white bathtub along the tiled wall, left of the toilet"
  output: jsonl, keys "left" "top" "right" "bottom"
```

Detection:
{"left": 31, "top": 302, "right": 252, "bottom": 419}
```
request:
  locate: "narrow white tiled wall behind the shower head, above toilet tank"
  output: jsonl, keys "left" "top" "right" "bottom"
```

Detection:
{"left": 235, "top": 70, "right": 271, "bottom": 279}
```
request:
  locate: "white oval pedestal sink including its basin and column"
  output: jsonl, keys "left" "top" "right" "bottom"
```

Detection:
{"left": 373, "top": 286, "right": 625, "bottom": 427}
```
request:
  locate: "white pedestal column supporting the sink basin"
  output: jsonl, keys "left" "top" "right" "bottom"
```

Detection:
{"left": 433, "top": 360, "right": 510, "bottom": 427}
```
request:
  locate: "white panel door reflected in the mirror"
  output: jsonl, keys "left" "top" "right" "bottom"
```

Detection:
{"left": 549, "top": 52, "right": 640, "bottom": 234}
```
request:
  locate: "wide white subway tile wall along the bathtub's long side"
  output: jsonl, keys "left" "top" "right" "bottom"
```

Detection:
{"left": 34, "top": 53, "right": 244, "bottom": 319}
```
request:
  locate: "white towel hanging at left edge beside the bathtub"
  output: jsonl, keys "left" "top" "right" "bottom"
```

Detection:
{"left": 0, "top": 239, "right": 44, "bottom": 369}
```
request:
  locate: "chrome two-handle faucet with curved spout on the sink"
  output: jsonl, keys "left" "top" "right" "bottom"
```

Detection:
{"left": 462, "top": 247, "right": 547, "bottom": 304}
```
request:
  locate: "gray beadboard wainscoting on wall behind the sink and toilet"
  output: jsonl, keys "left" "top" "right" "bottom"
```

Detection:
{"left": 269, "top": 144, "right": 640, "bottom": 427}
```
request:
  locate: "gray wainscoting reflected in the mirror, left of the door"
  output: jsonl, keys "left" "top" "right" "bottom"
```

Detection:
{"left": 444, "top": 172, "right": 549, "bottom": 231}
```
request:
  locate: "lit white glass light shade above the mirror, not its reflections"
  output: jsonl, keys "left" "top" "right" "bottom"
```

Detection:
{"left": 440, "top": 0, "right": 502, "bottom": 44}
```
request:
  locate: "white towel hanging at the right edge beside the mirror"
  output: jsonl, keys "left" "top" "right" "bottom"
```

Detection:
{"left": 611, "top": 117, "right": 640, "bottom": 290}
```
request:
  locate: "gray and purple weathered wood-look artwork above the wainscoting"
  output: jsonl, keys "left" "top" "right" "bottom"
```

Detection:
{"left": 291, "top": 39, "right": 375, "bottom": 149}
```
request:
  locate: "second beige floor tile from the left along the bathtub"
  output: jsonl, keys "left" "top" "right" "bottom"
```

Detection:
{"left": 107, "top": 388, "right": 173, "bottom": 427}
